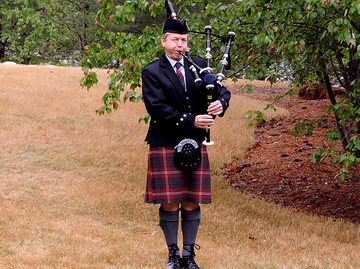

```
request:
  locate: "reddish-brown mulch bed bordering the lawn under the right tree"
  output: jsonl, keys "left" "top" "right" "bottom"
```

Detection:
{"left": 224, "top": 87, "right": 360, "bottom": 224}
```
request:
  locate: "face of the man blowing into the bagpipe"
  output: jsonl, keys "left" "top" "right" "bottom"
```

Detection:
{"left": 161, "top": 33, "right": 188, "bottom": 61}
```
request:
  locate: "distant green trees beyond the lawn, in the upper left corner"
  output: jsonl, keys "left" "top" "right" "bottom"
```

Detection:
{"left": 0, "top": 0, "right": 102, "bottom": 64}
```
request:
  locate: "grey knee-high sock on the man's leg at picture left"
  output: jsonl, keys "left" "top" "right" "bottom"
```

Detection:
{"left": 159, "top": 206, "right": 179, "bottom": 247}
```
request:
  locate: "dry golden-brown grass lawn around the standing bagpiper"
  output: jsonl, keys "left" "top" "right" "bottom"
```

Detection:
{"left": 0, "top": 65, "right": 360, "bottom": 269}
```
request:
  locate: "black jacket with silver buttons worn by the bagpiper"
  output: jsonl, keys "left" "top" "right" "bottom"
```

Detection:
{"left": 142, "top": 54, "right": 231, "bottom": 146}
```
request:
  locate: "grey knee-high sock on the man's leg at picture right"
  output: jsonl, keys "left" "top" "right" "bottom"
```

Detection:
{"left": 181, "top": 206, "right": 201, "bottom": 257}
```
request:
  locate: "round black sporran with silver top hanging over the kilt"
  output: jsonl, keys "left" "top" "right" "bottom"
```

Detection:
{"left": 175, "top": 138, "right": 201, "bottom": 170}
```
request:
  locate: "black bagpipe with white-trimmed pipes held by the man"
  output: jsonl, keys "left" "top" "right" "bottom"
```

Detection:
{"left": 165, "top": 0, "right": 235, "bottom": 146}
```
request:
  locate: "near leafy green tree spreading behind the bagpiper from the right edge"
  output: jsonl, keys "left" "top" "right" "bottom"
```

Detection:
{"left": 82, "top": 0, "right": 360, "bottom": 177}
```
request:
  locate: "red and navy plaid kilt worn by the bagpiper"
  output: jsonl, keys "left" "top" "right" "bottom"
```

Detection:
{"left": 145, "top": 144, "right": 211, "bottom": 204}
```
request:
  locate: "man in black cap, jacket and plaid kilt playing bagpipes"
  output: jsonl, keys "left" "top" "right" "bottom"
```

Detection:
{"left": 142, "top": 19, "right": 231, "bottom": 269}
